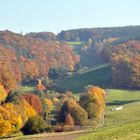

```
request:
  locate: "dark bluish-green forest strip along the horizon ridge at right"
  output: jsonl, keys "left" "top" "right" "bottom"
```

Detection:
{"left": 57, "top": 26, "right": 140, "bottom": 41}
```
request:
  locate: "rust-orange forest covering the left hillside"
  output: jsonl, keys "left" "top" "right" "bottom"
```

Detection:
{"left": 0, "top": 31, "right": 80, "bottom": 91}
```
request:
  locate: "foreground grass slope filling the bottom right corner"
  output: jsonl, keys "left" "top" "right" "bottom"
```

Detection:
{"left": 76, "top": 121, "right": 140, "bottom": 140}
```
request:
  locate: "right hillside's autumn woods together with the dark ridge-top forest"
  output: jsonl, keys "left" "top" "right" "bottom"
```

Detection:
{"left": 58, "top": 26, "right": 140, "bottom": 88}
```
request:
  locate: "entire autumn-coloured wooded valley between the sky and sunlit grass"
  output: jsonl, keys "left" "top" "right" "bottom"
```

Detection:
{"left": 0, "top": 26, "right": 140, "bottom": 138}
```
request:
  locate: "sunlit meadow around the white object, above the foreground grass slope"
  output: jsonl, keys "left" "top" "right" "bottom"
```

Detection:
{"left": 105, "top": 89, "right": 140, "bottom": 126}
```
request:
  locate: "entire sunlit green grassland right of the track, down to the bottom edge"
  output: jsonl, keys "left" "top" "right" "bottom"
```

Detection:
{"left": 76, "top": 89, "right": 140, "bottom": 140}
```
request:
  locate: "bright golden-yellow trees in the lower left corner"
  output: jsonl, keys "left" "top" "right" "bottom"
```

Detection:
{"left": 0, "top": 100, "right": 36, "bottom": 137}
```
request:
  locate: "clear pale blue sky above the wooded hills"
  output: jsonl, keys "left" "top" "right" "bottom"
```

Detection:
{"left": 0, "top": 0, "right": 140, "bottom": 33}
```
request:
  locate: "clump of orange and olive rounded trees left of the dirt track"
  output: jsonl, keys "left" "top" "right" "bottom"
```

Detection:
{"left": 59, "top": 85, "right": 105, "bottom": 126}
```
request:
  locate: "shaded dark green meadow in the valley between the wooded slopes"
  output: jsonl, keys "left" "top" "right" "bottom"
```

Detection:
{"left": 57, "top": 65, "right": 111, "bottom": 93}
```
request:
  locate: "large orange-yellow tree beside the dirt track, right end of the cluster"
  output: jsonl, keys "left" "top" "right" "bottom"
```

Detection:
{"left": 80, "top": 86, "right": 105, "bottom": 119}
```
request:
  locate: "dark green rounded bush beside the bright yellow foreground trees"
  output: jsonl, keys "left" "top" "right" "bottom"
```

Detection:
{"left": 21, "top": 116, "right": 46, "bottom": 135}
